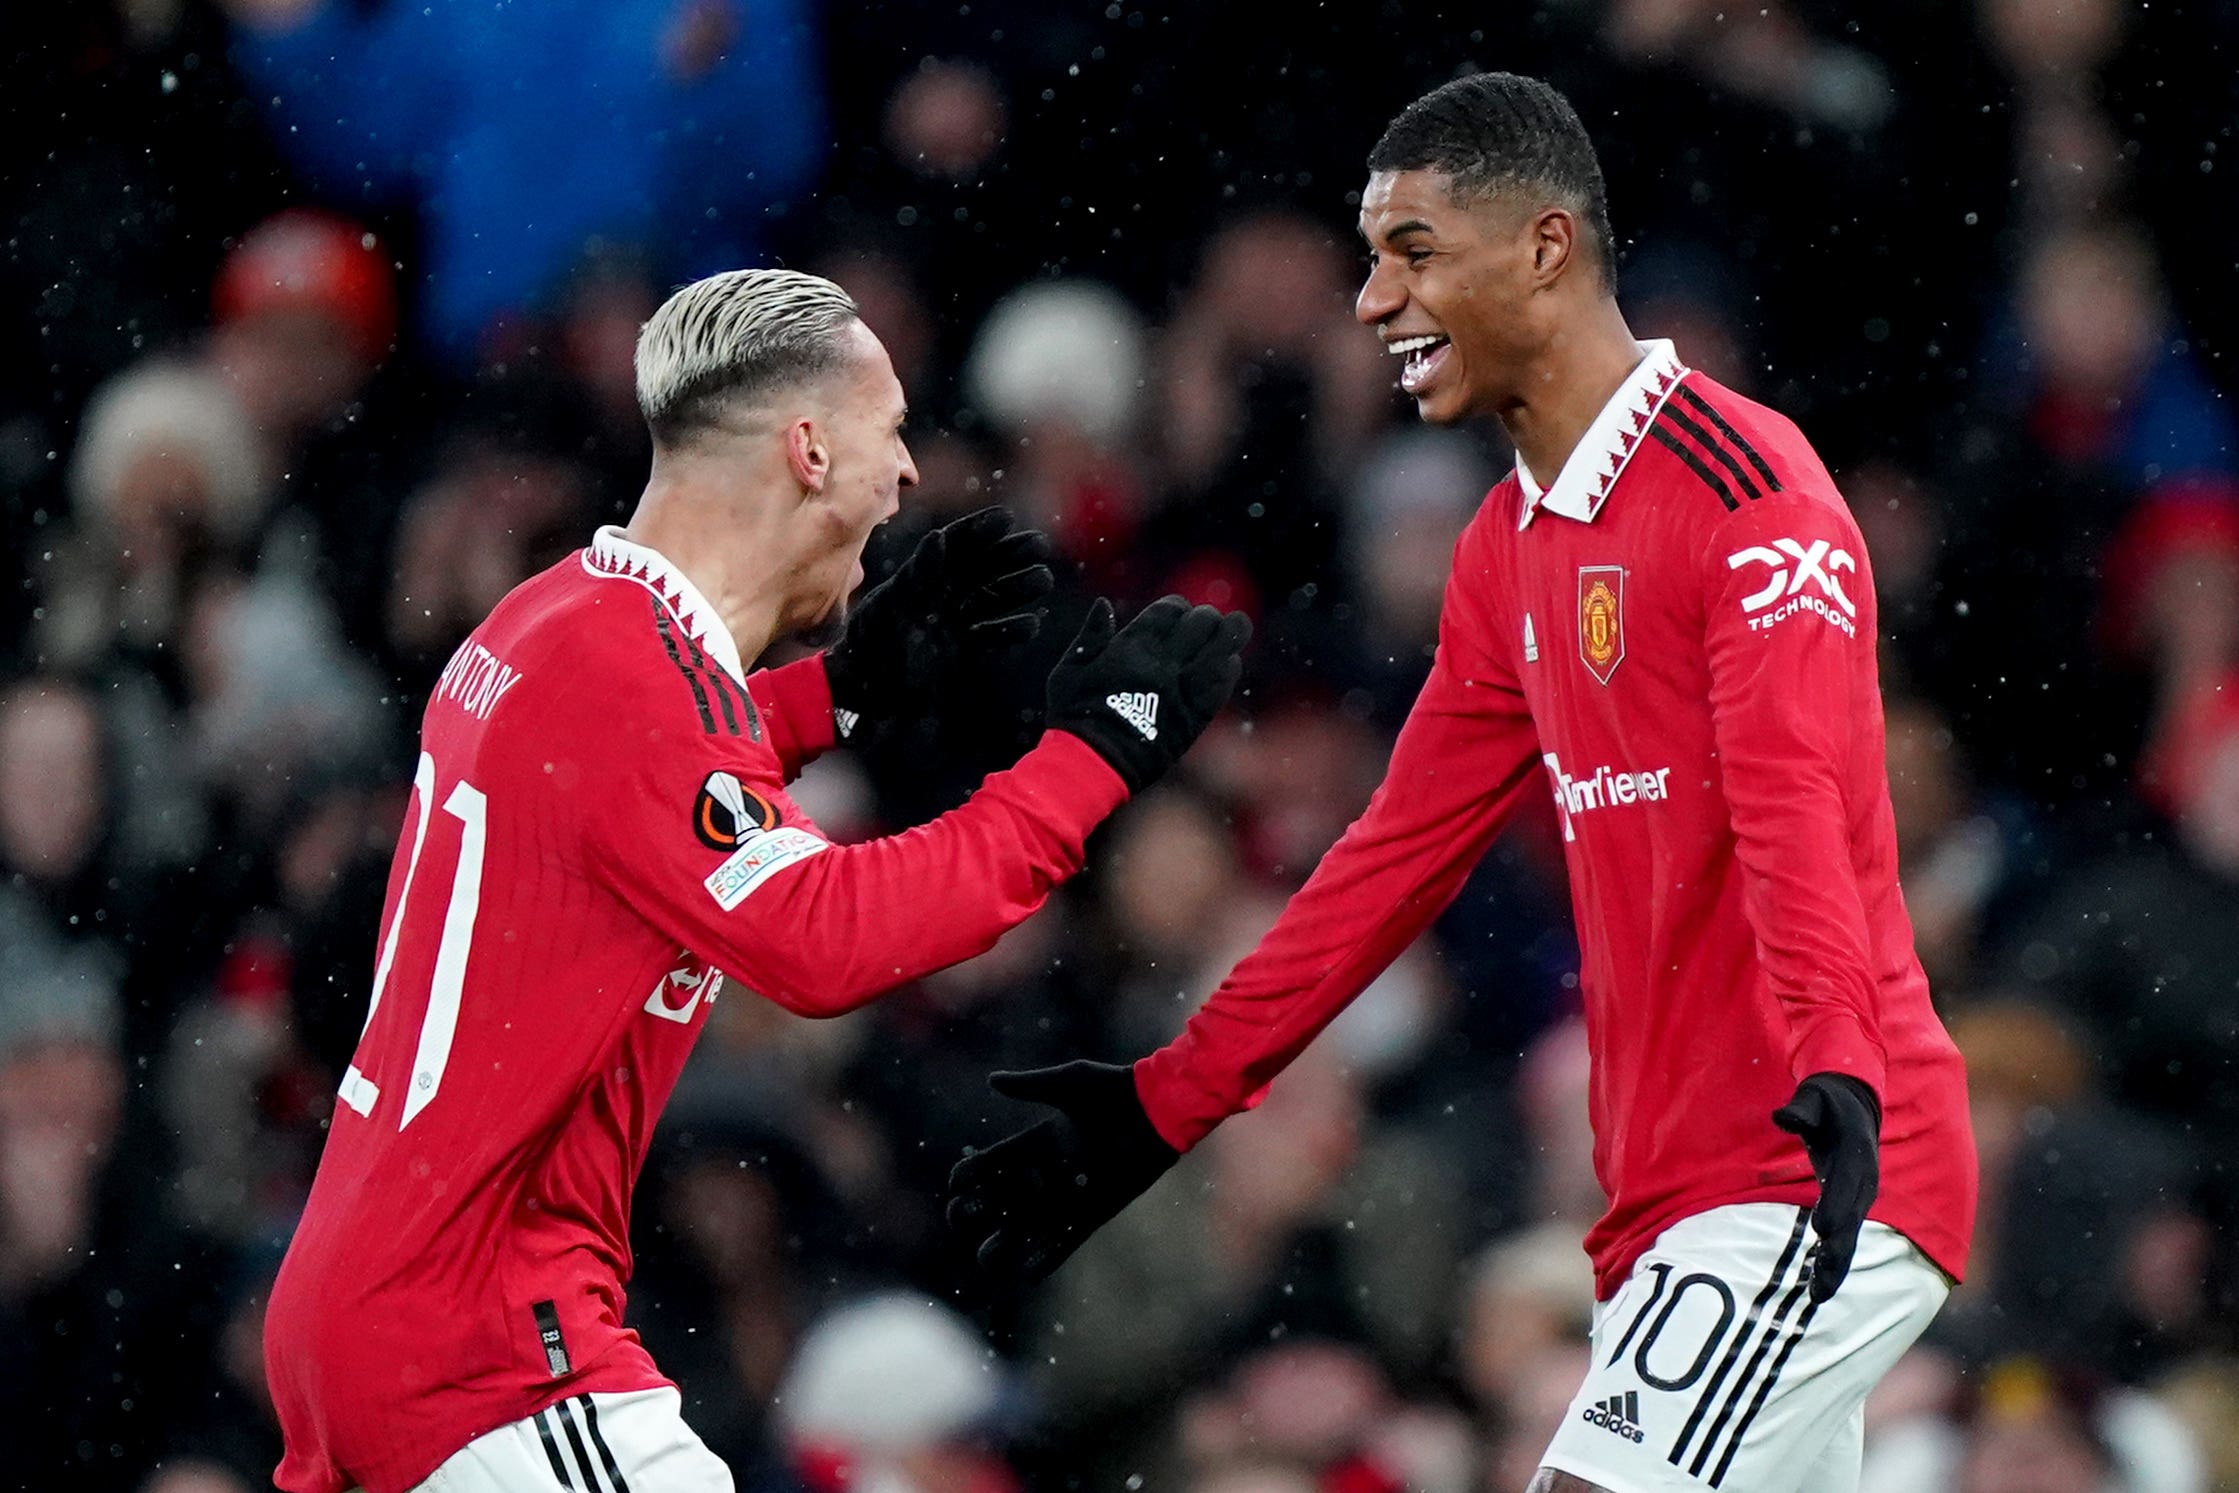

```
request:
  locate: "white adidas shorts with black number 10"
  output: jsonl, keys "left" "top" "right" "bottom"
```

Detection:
{"left": 1540, "top": 1202, "right": 1950, "bottom": 1493}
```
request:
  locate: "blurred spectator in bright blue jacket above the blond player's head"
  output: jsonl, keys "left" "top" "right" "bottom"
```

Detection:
{"left": 226, "top": 0, "right": 824, "bottom": 360}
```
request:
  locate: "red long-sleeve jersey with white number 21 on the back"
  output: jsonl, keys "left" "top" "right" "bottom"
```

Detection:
{"left": 264, "top": 530, "right": 1126, "bottom": 1493}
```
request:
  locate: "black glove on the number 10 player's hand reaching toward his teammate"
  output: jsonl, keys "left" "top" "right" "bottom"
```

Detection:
{"left": 949, "top": 1061, "right": 1182, "bottom": 1285}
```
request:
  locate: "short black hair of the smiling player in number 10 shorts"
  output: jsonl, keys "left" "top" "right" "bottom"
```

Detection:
{"left": 1368, "top": 72, "right": 1617, "bottom": 287}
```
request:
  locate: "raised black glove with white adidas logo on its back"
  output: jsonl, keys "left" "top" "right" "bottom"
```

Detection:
{"left": 1046, "top": 595, "right": 1252, "bottom": 792}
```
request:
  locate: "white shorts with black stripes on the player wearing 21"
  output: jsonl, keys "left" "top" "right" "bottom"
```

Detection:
{"left": 394, "top": 1388, "right": 732, "bottom": 1493}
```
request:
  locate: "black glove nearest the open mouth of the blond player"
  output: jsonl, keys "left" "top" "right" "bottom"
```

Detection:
{"left": 824, "top": 508, "right": 1057, "bottom": 736}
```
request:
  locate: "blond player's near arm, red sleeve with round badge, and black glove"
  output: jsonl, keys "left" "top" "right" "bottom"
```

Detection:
{"left": 582, "top": 598, "right": 1249, "bottom": 1016}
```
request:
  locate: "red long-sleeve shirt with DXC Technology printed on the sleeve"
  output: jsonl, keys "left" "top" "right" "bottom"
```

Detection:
{"left": 1135, "top": 342, "right": 1975, "bottom": 1296}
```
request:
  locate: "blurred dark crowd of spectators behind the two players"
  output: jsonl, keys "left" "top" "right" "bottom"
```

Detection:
{"left": 0, "top": 0, "right": 2239, "bottom": 1493}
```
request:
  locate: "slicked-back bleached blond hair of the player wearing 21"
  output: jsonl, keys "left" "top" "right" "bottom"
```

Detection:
{"left": 636, "top": 269, "right": 860, "bottom": 445}
